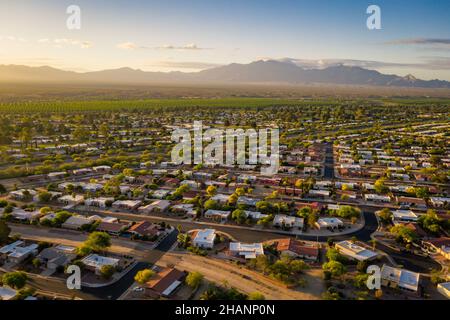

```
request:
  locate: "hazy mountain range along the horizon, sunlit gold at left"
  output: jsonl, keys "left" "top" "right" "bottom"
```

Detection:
{"left": 0, "top": 60, "right": 450, "bottom": 88}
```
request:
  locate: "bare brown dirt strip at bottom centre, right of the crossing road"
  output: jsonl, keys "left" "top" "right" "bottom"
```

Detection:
{"left": 159, "top": 253, "right": 324, "bottom": 300}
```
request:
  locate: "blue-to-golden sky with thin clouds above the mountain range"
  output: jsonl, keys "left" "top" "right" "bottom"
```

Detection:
{"left": 0, "top": 0, "right": 450, "bottom": 80}
